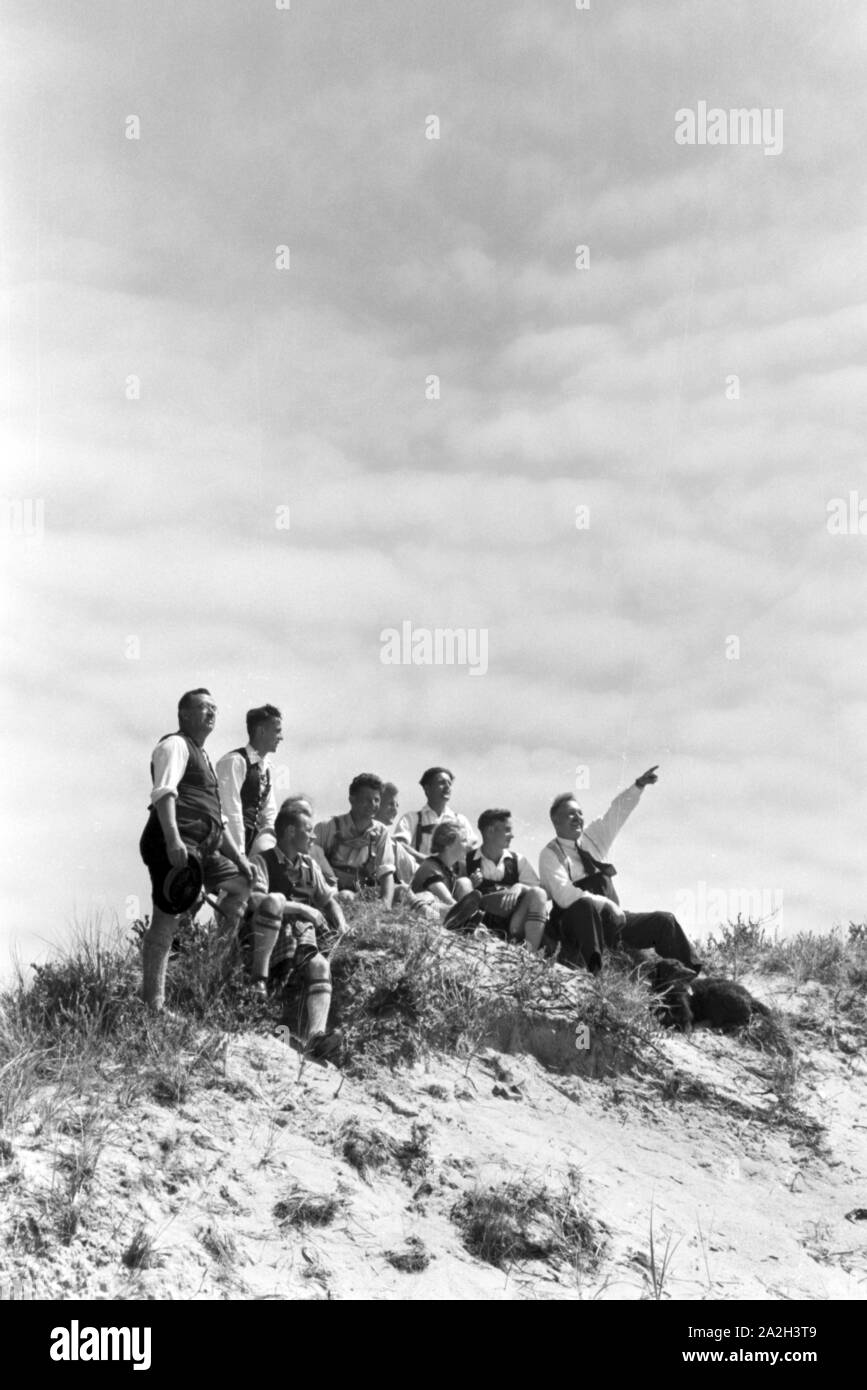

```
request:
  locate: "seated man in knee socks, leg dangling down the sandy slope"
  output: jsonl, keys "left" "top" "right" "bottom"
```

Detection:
{"left": 247, "top": 806, "right": 346, "bottom": 1058}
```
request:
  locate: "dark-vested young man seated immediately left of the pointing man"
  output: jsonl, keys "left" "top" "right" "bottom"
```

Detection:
{"left": 467, "top": 809, "right": 547, "bottom": 954}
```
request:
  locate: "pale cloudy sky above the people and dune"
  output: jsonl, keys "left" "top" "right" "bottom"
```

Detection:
{"left": 0, "top": 0, "right": 867, "bottom": 959}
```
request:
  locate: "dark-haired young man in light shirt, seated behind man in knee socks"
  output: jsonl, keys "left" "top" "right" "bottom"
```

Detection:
{"left": 314, "top": 773, "right": 395, "bottom": 908}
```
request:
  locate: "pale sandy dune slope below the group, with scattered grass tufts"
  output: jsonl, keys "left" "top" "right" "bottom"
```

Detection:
{"left": 0, "top": 979, "right": 867, "bottom": 1300}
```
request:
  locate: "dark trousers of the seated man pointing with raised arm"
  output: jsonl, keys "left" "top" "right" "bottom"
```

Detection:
{"left": 549, "top": 898, "right": 699, "bottom": 972}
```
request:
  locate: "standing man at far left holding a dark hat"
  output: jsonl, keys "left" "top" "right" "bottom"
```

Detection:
{"left": 139, "top": 689, "right": 253, "bottom": 1013}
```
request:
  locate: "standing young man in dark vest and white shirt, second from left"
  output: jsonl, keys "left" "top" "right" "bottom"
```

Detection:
{"left": 217, "top": 705, "right": 283, "bottom": 853}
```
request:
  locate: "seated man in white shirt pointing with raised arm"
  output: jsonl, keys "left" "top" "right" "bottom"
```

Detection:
{"left": 539, "top": 767, "right": 702, "bottom": 973}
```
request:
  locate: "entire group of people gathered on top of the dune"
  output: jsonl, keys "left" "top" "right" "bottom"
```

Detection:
{"left": 140, "top": 688, "right": 702, "bottom": 1059}
